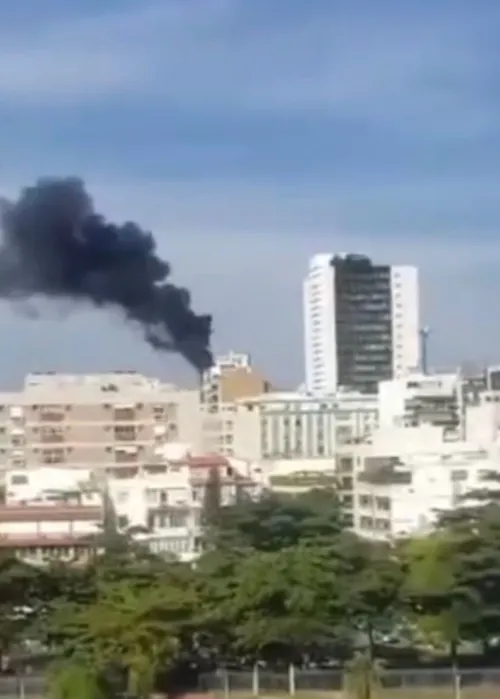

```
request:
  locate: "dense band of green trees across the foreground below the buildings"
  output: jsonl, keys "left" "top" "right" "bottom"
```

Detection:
{"left": 0, "top": 486, "right": 500, "bottom": 699}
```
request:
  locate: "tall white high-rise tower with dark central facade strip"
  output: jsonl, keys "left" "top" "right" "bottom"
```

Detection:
{"left": 304, "top": 253, "right": 420, "bottom": 394}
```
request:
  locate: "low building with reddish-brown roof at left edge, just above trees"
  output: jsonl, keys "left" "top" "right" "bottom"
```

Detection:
{"left": 0, "top": 502, "right": 102, "bottom": 563}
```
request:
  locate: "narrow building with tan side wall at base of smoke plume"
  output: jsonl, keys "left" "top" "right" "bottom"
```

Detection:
{"left": 200, "top": 352, "right": 271, "bottom": 456}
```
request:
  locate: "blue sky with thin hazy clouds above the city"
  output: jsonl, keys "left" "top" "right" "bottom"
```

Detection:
{"left": 0, "top": 0, "right": 500, "bottom": 384}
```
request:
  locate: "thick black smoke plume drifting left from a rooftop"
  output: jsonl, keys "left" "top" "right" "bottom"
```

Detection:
{"left": 0, "top": 178, "right": 212, "bottom": 371}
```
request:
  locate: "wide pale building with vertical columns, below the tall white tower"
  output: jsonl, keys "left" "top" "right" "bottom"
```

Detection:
{"left": 233, "top": 392, "right": 378, "bottom": 461}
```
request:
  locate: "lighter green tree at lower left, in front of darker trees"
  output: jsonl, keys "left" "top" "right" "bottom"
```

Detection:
{"left": 48, "top": 566, "right": 197, "bottom": 697}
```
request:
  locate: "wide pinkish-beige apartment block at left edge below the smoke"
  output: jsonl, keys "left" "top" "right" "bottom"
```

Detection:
{"left": 0, "top": 372, "right": 201, "bottom": 472}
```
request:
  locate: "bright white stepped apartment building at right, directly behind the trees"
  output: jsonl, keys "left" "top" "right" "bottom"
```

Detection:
{"left": 353, "top": 424, "right": 500, "bottom": 540}
